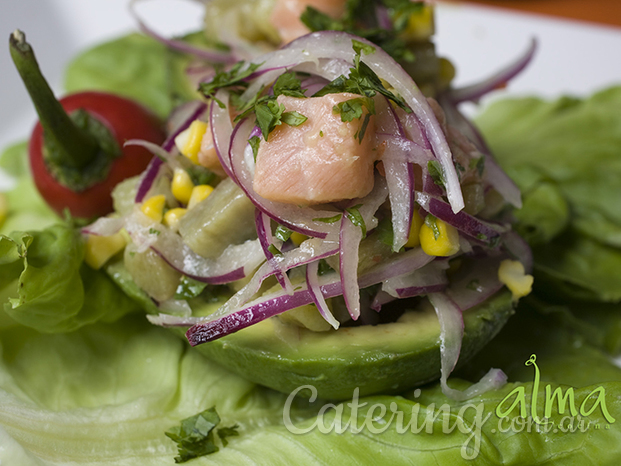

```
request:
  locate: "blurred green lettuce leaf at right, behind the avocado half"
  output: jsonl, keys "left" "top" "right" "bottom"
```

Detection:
{"left": 477, "top": 86, "right": 621, "bottom": 354}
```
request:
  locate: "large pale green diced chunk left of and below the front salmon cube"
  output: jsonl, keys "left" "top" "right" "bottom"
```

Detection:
{"left": 179, "top": 178, "right": 256, "bottom": 258}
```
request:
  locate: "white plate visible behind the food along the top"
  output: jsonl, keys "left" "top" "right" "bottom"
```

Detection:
{"left": 0, "top": 0, "right": 621, "bottom": 182}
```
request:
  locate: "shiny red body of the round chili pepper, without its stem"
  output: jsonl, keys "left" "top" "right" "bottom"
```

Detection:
{"left": 28, "top": 92, "right": 165, "bottom": 218}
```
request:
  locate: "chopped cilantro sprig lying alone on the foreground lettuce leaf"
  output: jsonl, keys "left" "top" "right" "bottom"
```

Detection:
{"left": 165, "top": 408, "right": 239, "bottom": 463}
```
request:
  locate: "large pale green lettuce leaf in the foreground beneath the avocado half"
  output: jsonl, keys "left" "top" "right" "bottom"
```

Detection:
{"left": 0, "top": 304, "right": 621, "bottom": 466}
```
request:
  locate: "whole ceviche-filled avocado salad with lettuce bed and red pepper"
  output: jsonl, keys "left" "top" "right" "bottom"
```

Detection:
{"left": 0, "top": 0, "right": 621, "bottom": 465}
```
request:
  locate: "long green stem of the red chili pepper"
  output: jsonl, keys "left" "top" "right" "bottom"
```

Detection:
{"left": 9, "top": 30, "right": 100, "bottom": 168}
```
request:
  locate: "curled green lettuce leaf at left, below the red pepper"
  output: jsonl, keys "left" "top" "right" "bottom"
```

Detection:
{"left": 0, "top": 223, "right": 140, "bottom": 332}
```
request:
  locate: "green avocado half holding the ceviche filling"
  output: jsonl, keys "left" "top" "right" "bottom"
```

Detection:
{"left": 108, "top": 263, "right": 513, "bottom": 400}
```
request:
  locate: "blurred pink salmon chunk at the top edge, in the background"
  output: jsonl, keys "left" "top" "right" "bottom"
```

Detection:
{"left": 270, "top": 0, "right": 345, "bottom": 44}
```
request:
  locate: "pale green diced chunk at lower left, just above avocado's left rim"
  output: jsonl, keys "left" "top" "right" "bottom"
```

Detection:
{"left": 124, "top": 243, "right": 181, "bottom": 302}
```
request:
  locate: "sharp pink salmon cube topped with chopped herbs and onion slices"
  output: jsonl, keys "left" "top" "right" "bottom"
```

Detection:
{"left": 253, "top": 93, "right": 377, "bottom": 205}
